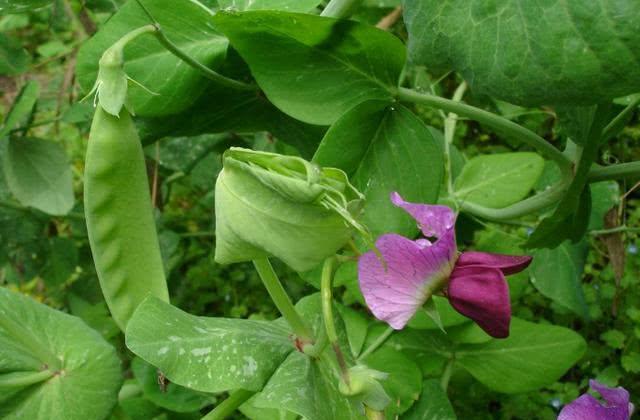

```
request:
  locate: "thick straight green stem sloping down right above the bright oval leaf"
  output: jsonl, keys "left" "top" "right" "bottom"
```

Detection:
{"left": 398, "top": 87, "right": 571, "bottom": 172}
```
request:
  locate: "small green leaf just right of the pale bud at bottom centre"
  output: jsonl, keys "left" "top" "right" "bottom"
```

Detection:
{"left": 363, "top": 346, "right": 422, "bottom": 418}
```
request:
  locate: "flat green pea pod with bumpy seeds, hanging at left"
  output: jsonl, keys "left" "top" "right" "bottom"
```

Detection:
{"left": 84, "top": 106, "right": 169, "bottom": 331}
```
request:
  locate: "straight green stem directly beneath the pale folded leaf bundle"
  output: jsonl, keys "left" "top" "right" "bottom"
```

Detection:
{"left": 253, "top": 258, "right": 313, "bottom": 342}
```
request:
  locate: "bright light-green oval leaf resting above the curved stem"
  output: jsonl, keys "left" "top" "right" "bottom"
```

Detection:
{"left": 455, "top": 152, "right": 544, "bottom": 209}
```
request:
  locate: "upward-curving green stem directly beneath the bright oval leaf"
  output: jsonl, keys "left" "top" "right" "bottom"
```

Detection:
{"left": 459, "top": 180, "right": 571, "bottom": 222}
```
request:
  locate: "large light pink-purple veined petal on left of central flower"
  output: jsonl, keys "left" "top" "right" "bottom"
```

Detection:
{"left": 358, "top": 229, "right": 456, "bottom": 330}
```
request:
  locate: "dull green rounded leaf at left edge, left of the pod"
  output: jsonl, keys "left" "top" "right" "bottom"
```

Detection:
{"left": 2, "top": 138, "right": 74, "bottom": 215}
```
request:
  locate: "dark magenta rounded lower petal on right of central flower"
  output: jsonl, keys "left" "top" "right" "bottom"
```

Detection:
{"left": 448, "top": 264, "right": 511, "bottom": 338}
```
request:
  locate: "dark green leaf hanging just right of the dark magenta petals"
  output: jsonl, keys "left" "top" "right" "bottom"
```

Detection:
{"left": 529, "top": 241, "right": 589, "bottom": 319}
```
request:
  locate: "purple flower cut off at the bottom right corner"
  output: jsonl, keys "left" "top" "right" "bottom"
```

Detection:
{"left": 558, "top": 379, "right": 633, "bottom": 420}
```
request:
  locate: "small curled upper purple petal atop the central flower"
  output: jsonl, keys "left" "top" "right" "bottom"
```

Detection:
{"left": 391, "top": 191, "right": 456, "bottom": 237}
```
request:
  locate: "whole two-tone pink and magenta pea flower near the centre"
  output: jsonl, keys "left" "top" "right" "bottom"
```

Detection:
{"left": 358, "top": 192, "right": 531, "bottom": 338}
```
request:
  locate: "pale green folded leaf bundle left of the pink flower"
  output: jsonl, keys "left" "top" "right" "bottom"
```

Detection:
{"left": 215, "top": 148, "right": 366, "bottom": 271}
